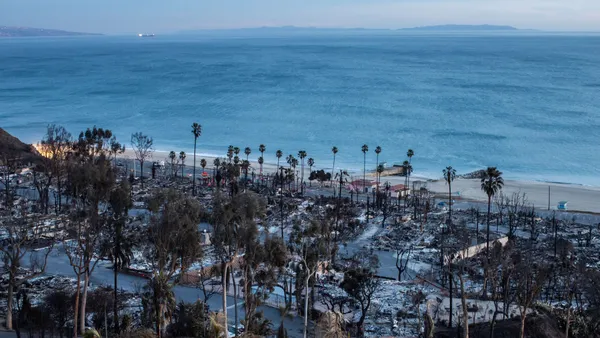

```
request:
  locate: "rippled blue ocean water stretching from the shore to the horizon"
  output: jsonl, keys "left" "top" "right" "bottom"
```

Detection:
{"left": 0, "top": 34, "right": 600, "bottom": 185}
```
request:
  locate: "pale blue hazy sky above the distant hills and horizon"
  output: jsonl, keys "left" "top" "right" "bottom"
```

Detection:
{"left": 0, "top": 0, "right": 600, "bottom": 34}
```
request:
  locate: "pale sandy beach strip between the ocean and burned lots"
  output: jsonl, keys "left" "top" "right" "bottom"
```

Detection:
{"left": 120, "top": 149, "right": 600, "bottom": 213}
